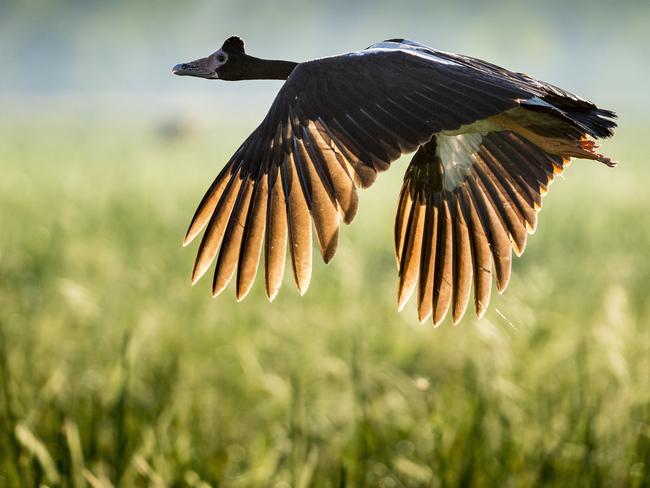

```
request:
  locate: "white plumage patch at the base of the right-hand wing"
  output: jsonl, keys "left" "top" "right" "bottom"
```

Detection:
{"left": 436, "top": 132, "right": 483, "bottom": 191}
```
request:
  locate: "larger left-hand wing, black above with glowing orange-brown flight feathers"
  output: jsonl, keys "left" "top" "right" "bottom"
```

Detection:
{"left": 185, "top": 43, "right": 576, "bottom": 299}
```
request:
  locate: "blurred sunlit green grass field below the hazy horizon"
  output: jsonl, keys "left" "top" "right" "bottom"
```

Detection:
{"left": 0, "top": 119, "right": 650, "bottom": 488}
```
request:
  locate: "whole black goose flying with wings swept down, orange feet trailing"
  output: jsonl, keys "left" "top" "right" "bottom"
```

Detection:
{"left": 173, "top": 37, "right": 616, "bottom": 325}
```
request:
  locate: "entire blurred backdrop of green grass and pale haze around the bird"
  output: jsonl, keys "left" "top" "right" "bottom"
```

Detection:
{"left": 0, "top": 0, "right": 650, "bottom": 488}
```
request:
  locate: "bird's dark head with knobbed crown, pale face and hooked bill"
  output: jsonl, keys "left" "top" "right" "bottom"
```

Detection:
{"left": 172, "top": 36, "right": 246, "bottom": 80}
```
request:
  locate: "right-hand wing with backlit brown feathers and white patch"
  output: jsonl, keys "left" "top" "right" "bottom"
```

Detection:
{"left": 395, "top": 131, "right": 568, "bottom": 325}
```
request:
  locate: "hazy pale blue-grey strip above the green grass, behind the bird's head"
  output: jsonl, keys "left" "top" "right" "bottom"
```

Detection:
{"left": 0, "top": 0, "right": 650, "bottom": 123}
